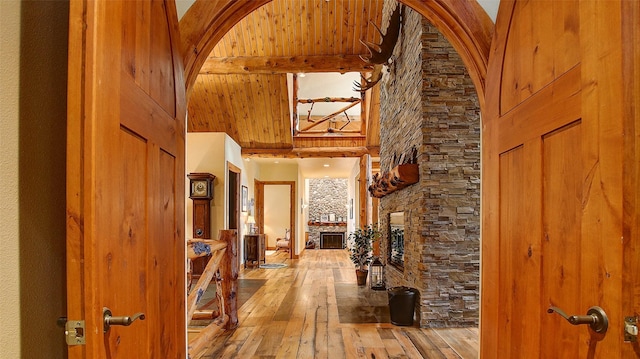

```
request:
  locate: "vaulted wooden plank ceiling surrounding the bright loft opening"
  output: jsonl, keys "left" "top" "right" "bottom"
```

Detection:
{"left": 188, "top": 0, "right": 388, "bottom": 157}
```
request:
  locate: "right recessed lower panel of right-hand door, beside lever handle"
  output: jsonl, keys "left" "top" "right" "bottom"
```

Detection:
{"left": 539, "top": 121, "right": 588, "bottom": 358}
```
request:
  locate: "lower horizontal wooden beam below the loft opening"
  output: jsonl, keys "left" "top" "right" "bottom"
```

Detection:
{"left": 242, "top": 147, "right": 371, "bottom": 158}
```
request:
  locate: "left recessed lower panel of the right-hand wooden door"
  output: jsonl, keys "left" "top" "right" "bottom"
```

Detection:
{"left": 496, "top": 142, "right": 540, "bottom": 357}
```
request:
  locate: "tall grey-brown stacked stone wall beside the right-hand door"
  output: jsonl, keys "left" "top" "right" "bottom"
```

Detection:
{"left": 380, "top": 1, "right": 480, "bottom": 327}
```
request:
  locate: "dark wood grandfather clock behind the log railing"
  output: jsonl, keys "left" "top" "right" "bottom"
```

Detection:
{"left": 187, "top": 173, "right": 216, "bottom": 282}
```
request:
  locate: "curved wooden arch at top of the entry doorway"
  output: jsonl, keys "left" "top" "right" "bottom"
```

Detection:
{"left": 180, "top": 0, "right": 494, "bottom": 108}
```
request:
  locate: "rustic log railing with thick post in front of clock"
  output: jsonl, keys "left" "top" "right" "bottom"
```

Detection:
{"left": 187, "top": 230, "right": 239, "bottom": 358}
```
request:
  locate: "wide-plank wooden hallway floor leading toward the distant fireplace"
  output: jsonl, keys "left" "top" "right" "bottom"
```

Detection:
{"left": 195, "top": 249, "right": 478, "bottom": 359}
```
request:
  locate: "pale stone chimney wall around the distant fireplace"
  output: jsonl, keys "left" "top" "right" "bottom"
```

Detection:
{"left": 309, "top": 178, "right": 348, "bottom": 249}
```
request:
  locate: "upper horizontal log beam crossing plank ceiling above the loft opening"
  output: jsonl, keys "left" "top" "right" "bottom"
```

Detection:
{"left": 200, "top": 55, "right": 371, "bottom": 75}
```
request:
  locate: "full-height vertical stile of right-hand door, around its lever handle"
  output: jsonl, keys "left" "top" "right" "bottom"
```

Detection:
{"left": 580, "top": 1, "right": 631, "bottom": 358}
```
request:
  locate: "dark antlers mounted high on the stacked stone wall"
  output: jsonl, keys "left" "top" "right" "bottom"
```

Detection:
{"left": 354, "top": 4, "right": 404, "bottom": 92}
